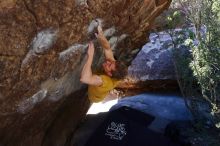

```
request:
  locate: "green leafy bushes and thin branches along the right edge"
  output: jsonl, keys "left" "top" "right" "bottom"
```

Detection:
{"left": 167, "top": 0, "right": 220, "bottom": 127}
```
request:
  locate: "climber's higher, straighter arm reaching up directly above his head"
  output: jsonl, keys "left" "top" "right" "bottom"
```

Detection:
{"left": 96, "top": 26, "right": 115, "bottom": 61}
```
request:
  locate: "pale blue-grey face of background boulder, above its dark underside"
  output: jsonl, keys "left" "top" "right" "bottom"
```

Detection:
{"left": 128, "top": 32, "right": 176, "bottom": 81}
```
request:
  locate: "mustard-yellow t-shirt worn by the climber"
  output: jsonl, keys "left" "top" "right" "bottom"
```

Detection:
{"left": 88, "top": 75, "right": 118, "bottom": 102}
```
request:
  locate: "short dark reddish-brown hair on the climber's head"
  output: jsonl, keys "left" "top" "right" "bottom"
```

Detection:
{"left": 111, "top": 61, "right": 128, "bottom": 80}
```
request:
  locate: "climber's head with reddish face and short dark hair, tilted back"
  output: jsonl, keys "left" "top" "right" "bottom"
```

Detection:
{"left": 102, "top": 59, "right": 127, "bottom": 79}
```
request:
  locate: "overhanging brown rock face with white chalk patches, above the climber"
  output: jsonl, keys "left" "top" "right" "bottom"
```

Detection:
{"left": 0, "top": 0, "right": 171, "bottom": 146}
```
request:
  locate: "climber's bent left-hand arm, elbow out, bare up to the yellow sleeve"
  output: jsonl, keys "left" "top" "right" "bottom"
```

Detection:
{"left": 80, "top": 42, "right": 102, "bottom": 86}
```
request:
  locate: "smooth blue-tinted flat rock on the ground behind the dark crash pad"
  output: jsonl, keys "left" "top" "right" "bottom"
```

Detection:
{"left": 111, "top": 93, "right": 192, "bottom": 120}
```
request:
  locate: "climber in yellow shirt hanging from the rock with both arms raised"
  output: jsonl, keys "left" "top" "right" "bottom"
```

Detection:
{"left": 80, "top": 26, "right": 127, "bottom": 102}
